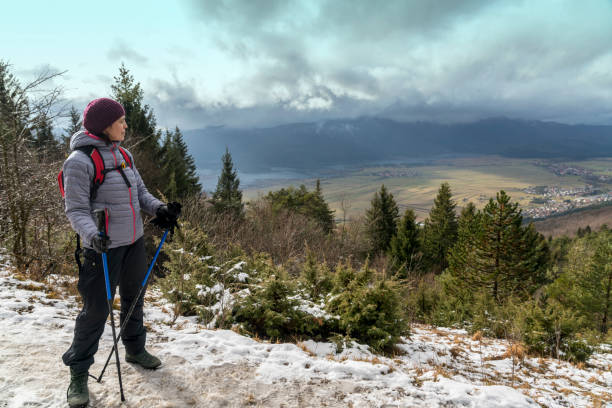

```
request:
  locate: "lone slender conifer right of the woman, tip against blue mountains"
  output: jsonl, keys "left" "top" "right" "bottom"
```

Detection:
{"left": 212, "top": 147, "right": 244, "bottom": 217}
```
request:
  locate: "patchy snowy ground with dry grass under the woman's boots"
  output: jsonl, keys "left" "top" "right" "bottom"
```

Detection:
{"left": 0, "top": 260, "right": 612, "bottom": 408}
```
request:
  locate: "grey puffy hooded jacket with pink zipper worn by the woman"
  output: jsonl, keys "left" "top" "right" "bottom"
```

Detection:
{"left": 63, "top": 131, "right": 163, "bottom": 248}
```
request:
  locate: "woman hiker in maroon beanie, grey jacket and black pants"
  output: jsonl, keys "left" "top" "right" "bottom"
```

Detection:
{"left": 62, "top": 98, "right": 180, "bottom": 406}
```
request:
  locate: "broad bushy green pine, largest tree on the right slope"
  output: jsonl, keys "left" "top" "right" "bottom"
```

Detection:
{"left": 448, "top": 190, "right": 549, "bottom": 302}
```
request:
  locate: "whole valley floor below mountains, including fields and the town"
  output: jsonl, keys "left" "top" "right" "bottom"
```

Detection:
{"left": 237, "top": 156, "right": 612, "bottom": 226}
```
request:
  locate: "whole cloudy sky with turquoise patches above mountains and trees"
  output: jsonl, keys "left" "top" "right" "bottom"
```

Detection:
{"left": 0, "top": 0, "right": 612, "bottom": 129}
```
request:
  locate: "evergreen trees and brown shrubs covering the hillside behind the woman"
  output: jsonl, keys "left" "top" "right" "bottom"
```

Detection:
{"left": 0, "top": 62, "right": 612, "bottom": 363}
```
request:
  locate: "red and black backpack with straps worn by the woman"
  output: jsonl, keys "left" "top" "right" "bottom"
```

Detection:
{"left": 57, "top": 145, "right": 134, "bottom": 272}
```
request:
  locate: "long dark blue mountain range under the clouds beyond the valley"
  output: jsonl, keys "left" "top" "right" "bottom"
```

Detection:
{"left": 184, "top": 117, "right": 612, "bottom": 171}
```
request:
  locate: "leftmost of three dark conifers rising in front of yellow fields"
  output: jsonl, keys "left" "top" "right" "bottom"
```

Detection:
{"left": 366, "top": 184, "right": 399, "bottom": 253}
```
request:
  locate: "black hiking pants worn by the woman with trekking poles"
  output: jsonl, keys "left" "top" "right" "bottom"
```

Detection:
{"left": 62, "top": 238, "right": 147, "bottom": 372}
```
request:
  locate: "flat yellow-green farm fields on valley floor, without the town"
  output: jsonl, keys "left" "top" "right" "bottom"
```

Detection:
{"left": 244, "top": 156, "right": 612, "bottom": 220}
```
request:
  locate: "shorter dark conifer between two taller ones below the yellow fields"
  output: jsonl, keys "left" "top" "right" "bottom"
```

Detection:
{"left": 389, "top": 208, "right": 420, "bottom": 278}
